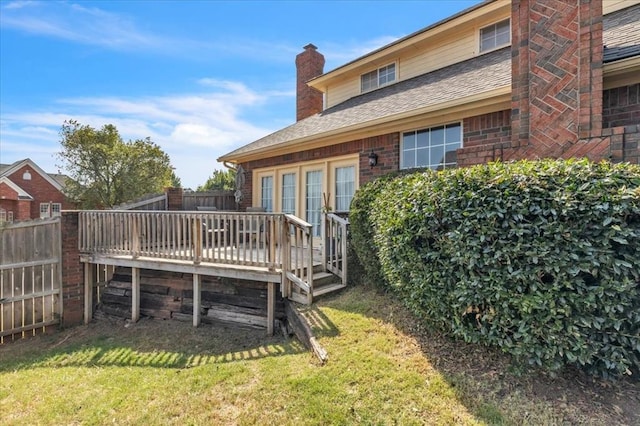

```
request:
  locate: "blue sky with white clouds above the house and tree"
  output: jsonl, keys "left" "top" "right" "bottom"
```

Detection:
{"left": 0, "top": 0, "right": 479, "bottom": 189}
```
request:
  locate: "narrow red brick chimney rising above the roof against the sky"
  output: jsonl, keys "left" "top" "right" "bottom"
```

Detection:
{"left": 296, "top": 44, "right": 324, "bottom": 121}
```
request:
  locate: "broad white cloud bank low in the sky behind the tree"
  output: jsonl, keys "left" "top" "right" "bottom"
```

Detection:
{"left": 0, "top": 80, "right": 275, "bottom": 189}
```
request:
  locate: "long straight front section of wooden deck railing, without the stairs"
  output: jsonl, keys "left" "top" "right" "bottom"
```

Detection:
{"left": 78, "top": 210, "right": 282, "bottom": 269}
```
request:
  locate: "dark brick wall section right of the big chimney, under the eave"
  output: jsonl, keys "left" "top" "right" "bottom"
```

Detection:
{"left": 602, "top": 83, "right": 640, "bottom": 128}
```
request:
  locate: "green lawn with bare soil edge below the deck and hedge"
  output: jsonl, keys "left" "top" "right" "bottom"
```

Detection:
{"left": 0, "top": 287, "right": 638, "bottom": 425}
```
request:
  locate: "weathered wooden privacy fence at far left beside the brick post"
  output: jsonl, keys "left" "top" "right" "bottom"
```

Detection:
{"left": 0, "top": 218, "right": 62, "bottom": 343}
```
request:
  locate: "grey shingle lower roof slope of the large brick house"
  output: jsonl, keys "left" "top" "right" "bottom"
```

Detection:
{"left": 218, "top": 5, "right": 640, "bottom": 161}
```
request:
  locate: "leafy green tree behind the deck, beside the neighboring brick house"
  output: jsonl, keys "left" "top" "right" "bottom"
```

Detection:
{"left": 58, "top": 120, "right": 173, "bottom": 208}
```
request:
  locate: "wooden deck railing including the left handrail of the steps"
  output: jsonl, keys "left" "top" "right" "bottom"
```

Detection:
{"left": 79, "top": 210, "right": 313, "bottom": 300}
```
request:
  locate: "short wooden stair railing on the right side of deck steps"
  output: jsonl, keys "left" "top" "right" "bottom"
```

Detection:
{"left": 322, "top": 213, "right": 349, "bottom": 285}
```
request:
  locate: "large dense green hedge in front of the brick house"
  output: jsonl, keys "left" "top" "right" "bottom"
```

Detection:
{"left": 351, "top": 160, "right": 640, "bottom": 376}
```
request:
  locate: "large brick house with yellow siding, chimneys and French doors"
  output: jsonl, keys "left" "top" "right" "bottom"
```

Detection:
{"left": 218, "top": 0, "right": 640, "bottom": 233}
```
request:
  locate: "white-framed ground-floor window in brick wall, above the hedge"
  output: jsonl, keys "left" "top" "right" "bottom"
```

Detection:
{"left": 400, "top": 123, "right": 462, "bottom": 170}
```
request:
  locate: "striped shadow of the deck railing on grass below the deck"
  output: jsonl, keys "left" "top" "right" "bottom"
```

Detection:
{"left": 0, "top": 318, "right": 306, "bottom": 372}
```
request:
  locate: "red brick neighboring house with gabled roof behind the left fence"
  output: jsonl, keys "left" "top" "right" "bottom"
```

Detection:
{"left": 0, "top": 158, "right": 75, "bottom": 222}
